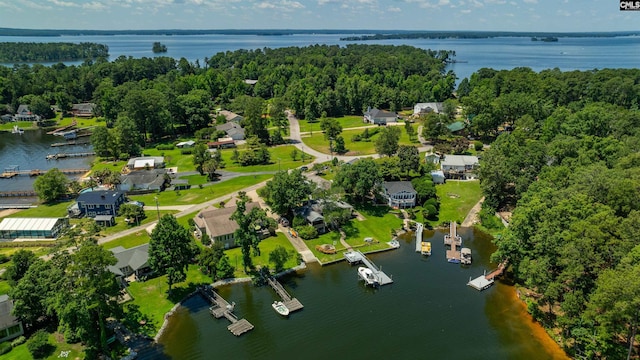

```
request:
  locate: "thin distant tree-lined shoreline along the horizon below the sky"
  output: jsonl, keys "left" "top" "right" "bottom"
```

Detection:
{"left": 0, "top": 28, "right": 640, "bottom": 41}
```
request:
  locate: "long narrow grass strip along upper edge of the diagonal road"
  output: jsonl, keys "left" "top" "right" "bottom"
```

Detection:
{"left": 129, "top": 174, "right": 273, "bottom": 206}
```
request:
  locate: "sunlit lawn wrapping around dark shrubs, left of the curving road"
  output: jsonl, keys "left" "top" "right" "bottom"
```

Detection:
{"left": 222, "top": 145, "right": 314, "bottom": 172}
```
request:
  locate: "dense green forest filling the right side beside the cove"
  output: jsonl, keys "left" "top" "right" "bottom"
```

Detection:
{"left": 458, "top": 68, "right": 640, "bottom": 359}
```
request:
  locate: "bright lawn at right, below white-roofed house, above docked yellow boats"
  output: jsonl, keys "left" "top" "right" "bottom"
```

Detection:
{"left": 428, "top": 180, "right": 482, "bottom": 226}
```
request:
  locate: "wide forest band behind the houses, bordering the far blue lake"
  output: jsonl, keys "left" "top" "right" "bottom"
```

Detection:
{"left": 0, "top": 45, "right": 456, "bottom": 142}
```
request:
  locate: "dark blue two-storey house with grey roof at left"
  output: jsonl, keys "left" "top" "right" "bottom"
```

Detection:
{"left": 68, "top": 190, "right": 125, "bottom": 219}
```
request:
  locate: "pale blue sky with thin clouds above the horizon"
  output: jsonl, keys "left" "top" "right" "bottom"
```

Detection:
{"left": 0, "top": 0, "right": 640, "bottom": 31}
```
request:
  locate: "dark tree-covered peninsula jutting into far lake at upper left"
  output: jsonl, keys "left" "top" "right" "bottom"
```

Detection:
{"left": 0, "top": 42, "right": 109, "bottom": 63}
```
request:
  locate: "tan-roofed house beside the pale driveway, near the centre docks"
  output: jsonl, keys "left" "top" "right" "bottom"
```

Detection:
{"left": 193, "top": 202, "right": 260, "bottom": 249}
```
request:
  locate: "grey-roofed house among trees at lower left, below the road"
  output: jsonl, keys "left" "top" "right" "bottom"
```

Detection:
{"left": 108, "top": 243, "right": 152, "bottom": 284}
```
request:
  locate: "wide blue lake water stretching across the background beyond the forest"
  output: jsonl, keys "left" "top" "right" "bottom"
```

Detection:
{"left": 0, "top": 34, "right": 640, "bottom": 79}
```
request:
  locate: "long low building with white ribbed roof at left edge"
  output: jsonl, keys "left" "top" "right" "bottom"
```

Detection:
{"left": 0, "top": 218, "right": 69, "bottom": 240}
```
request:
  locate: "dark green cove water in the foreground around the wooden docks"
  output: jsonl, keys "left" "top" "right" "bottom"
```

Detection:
{"left": 160, "top": 229, "right": 566, "bottom": 359}
